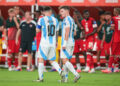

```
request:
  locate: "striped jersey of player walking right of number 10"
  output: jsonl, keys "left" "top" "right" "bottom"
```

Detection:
{"left": 62, "top": 16, "right": 76, "bottom": 46}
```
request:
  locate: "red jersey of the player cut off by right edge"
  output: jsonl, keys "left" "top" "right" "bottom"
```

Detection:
{"left": 113, "top": 16, "right": 120, "bottom": 42}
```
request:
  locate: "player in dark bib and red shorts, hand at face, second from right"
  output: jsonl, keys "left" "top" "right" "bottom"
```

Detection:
{"left": 101, "top": 11, "right": 114, "bottom": 72}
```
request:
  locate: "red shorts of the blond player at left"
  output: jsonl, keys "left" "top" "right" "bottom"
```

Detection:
{"left": 8, "top": 40, "right": 20, "bottom": 54}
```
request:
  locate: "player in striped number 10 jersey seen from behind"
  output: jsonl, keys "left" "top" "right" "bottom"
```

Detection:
{"left": 36, "top": 7, "right": 62, "bottom": 82}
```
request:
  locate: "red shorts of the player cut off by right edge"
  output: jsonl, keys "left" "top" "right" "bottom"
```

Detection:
{"left": 111, "top": 42, "right": 120, "bottom": 55}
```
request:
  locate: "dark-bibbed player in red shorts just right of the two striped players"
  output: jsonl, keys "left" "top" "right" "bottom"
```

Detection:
{"left": 73, "top": 11, "right": 82, "bottom": 73}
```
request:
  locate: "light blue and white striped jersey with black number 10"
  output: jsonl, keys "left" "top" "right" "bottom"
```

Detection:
{"left": 37, "top": 16, "right": 59, "bottom": 47}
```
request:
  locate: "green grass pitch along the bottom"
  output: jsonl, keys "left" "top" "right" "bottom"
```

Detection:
{"left": 0, "top": 69, "right": 120, "bottom": 86}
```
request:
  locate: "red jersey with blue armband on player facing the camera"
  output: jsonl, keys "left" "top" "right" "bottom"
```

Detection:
{"left": 81, "top": 17, "right": 97, "bottom": 34}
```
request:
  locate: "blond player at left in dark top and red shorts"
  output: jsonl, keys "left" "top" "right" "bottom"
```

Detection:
{"left": 5, "top": 8, "right": 20, "bottom": 71}
